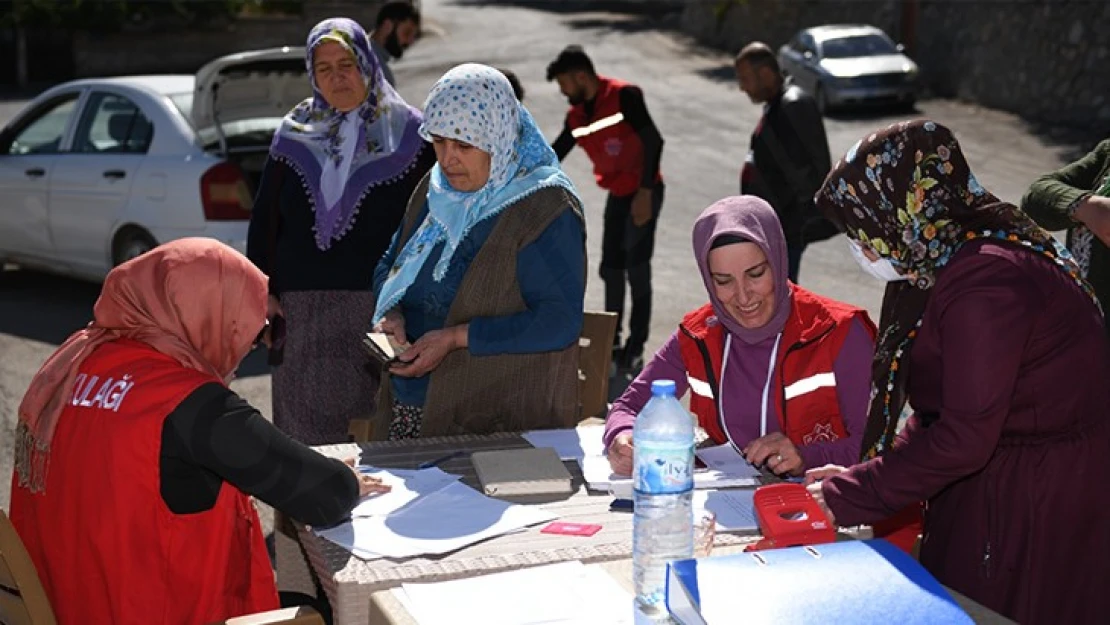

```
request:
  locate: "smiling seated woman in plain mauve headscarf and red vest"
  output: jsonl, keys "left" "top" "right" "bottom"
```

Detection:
{"left": 605, "top": 195, "right": 875, "bottom": 476}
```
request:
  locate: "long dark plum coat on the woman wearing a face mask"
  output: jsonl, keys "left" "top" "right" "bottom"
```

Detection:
{"left": 821, "top": 241, "right": 1110, "bottom": 624}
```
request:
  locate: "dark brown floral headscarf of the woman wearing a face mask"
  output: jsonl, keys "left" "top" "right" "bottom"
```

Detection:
{"left": 816, "top": 120, "right": 1097, "bottom": 458}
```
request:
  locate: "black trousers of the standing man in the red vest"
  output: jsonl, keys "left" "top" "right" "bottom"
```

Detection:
{"left": 599, "top": 182, "right": 665, "bottom": 357}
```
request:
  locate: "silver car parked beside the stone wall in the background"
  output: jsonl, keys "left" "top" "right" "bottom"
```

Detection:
{"left": 778, "top": 24, "right": 918, "bottom": 112}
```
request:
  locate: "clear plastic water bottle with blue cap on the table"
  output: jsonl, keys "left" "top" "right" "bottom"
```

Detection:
{"left": 632, "top": 380, "right": 694, "bottom": 619}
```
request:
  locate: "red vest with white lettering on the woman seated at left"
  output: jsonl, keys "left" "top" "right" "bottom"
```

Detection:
{"left": 11, "top": 340, "right": 279, "bottom": 625}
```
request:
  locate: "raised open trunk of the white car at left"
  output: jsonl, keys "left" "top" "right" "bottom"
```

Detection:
{"left": 190, "top": 47, "right": 312, "bottom": 195}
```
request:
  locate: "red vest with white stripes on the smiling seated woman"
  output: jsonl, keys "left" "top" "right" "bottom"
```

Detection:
{"left": 678, "top": 284, "right": 875, "bottom": 446}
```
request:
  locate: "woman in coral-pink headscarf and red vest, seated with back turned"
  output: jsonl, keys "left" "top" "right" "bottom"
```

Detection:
{"left": 11, "top": 239, "right": 382, "bottom": 625}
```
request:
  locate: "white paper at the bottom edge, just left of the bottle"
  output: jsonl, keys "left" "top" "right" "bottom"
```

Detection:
{"left": 394, "top": 561, "right": 633, "bottom": 625}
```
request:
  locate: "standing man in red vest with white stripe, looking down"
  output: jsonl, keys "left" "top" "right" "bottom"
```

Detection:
{"left": 547, "top": 46, "right": 664, "bottom": 373}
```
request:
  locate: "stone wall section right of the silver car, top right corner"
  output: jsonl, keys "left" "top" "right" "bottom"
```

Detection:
{"left": 917, "top": 0, "right": 1110, "bottom": 132}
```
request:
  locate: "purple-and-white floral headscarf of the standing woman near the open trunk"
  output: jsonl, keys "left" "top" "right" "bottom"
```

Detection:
{"left": 270, "top": 18, "right": 423, "bottom": 251}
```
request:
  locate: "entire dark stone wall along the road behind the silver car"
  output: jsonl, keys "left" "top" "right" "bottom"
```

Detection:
{"left": 683, "top": 0, "right": 1110, "bottom": 138}
